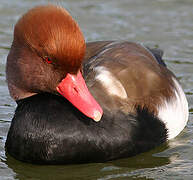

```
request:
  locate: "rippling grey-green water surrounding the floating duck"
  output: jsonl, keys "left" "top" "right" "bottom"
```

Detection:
{"left": 0, "top": 0, "right": 193, "bottom": 180}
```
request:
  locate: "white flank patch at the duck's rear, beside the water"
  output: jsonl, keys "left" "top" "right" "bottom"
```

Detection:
{"left": 158, "top": 78, "right": 189, "bottom": 139}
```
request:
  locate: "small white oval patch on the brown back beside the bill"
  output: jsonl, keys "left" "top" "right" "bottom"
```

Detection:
{"left": 95, "top": 66, "right": 127, "bottom": 99}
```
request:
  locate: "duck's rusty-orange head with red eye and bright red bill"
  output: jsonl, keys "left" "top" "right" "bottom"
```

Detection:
{"left": 6, "top": 5, "right": 103, "bottom": 121}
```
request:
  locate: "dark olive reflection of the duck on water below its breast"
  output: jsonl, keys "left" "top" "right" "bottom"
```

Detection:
{"left": 6, "top": 144, "right": 171, "bottom": 180}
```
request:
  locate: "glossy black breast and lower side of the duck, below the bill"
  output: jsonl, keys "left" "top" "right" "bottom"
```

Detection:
{"left": 6, "top": 94, "right": 167, "bottom": 164}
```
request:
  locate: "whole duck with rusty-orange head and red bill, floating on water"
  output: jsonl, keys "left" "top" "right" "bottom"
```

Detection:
{"left": 5, "top": 4, "right": 188, "bottom": 164}
